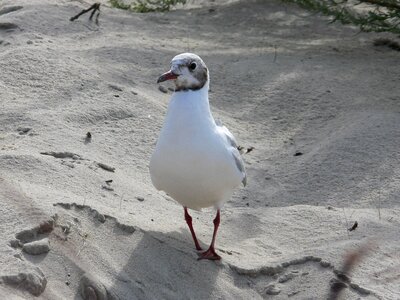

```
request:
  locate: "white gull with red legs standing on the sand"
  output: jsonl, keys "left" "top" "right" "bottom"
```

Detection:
{"left": 149, "top": 53, "right": 247, "bottom": 260}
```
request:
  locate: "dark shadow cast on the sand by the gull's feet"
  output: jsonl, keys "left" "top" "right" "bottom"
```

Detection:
{"left": 107, "top": 231, "right": 223, "bottom": 299}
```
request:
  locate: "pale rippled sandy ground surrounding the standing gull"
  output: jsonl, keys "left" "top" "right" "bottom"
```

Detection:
{"left": 0, "top": 0, "right": 400, "bottom": 299}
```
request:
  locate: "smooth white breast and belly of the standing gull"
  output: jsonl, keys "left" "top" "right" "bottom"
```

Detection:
{"left": 150, "top": 87, "right": 243, "bottom": 209}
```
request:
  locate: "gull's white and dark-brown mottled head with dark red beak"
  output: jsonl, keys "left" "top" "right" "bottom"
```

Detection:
{"left": 157, "top": 53, "right": 209, "bottom": 91}
